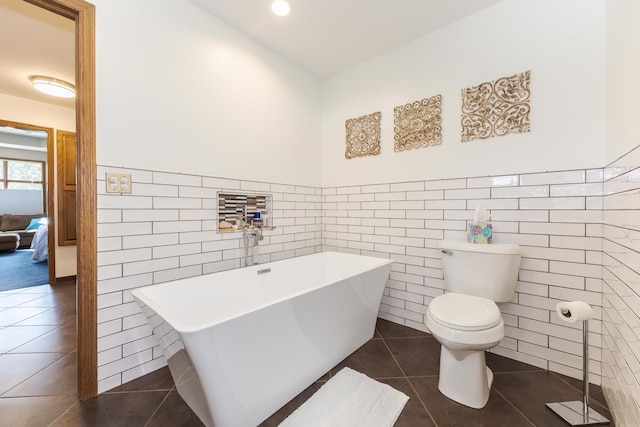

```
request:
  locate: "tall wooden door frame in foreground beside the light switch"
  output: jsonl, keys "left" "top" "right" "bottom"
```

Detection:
{"left": 25, "top": 0, "right": 98, "bottom": 400}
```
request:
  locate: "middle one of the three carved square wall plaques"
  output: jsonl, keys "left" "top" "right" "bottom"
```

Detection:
{"left": 393, "top": 95, "right": 442, "bottom": 151}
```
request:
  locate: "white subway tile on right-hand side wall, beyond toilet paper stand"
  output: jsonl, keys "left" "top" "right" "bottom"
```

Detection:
{"left": 602, "top": 147, "right": 640, "bottom": 426}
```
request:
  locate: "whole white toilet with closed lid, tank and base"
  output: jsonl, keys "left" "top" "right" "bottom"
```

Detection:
{"left": 426, "top": 240, "right": 520, "bottom": 409}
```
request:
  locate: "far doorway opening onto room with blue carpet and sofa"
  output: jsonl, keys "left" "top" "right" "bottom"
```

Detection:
{"left": 0, "top": 119, "right": 56, "bottom": 290}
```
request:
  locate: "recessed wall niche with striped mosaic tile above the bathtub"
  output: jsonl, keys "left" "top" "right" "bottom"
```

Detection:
{"left": 218, "top": 192, "right": 273, "bottom": 232}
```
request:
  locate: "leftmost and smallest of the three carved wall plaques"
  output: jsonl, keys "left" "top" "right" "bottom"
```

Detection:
{"left": 344, "top": 112, "right": 382, "bottom": 159}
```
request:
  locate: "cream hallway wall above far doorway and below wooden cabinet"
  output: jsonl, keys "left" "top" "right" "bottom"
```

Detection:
{"left": 0, "top": 93, "right": 76, "bottom": 277}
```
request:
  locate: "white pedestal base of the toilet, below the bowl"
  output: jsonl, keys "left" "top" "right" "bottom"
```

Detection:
{"left": 438, "top": 346, "right": 493, "bottom": 409}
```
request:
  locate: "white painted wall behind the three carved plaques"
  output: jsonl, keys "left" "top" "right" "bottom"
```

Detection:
{"left": 322, "top": 0, "right": 606, "bottom": 187}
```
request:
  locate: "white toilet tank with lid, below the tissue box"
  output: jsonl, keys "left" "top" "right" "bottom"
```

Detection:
{"left": 440, "top": 240, "right": 520, "bottom": 302}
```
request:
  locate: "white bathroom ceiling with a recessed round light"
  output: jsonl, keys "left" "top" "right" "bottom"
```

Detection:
{"left": 191, "top": 0, "right": 501, "bottom": 79}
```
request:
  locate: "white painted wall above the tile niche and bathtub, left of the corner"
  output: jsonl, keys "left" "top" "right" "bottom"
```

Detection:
{"left": 93, "top": 0, "right": 320, "bottom": 189}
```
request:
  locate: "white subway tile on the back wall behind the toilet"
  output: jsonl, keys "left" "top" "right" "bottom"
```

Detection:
{"left": 322, "top": 169, "right": 604, "bottom": 384}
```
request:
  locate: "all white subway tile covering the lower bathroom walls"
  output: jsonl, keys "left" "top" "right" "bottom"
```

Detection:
{"left": 98, "top": 163, "right": 640, "bottom": 408}
